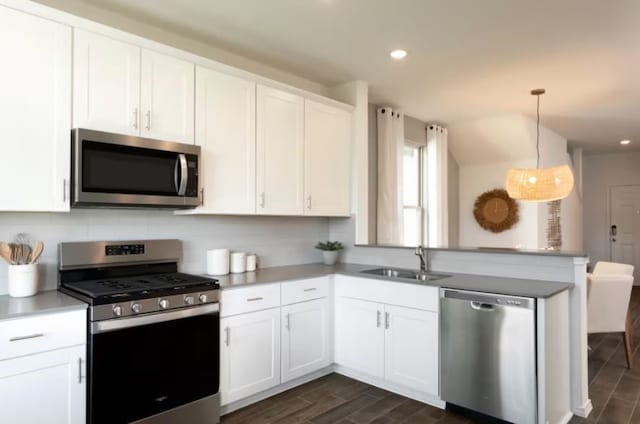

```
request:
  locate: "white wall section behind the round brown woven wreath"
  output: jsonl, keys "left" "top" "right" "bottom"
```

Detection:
{"left": 459, "top": 160, "right": 539, "bottom": 249}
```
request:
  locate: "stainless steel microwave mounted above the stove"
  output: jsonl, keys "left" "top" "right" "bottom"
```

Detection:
{"left": 71, "top": 128, "right": 200, "bottom": 209}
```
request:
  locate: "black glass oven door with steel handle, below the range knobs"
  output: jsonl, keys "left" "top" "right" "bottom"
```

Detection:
{"left": 87, "top": 304, "right": 220, "bottom": 424}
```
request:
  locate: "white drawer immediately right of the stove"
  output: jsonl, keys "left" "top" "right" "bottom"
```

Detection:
{"left": 220, "top": 284, "right": 280, "bottom": 317}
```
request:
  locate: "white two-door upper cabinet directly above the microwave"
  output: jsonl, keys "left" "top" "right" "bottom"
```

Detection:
{"left": 73, "top": 29, "right": 195, "bottom": 143}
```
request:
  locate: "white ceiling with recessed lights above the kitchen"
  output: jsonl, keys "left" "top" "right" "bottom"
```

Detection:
{"left": 83, "top": 0, "right": 640, "bottom": 152}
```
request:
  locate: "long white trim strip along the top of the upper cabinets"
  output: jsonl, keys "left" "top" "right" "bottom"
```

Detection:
{"left": 0, "top": 0, "right": 354, "bottom": 112}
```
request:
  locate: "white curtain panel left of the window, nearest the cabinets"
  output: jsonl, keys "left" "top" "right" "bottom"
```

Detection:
{"left": 377, "top": 107, "right": 404, "bottom": 245}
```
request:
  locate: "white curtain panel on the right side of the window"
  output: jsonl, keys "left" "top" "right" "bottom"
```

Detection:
{"left": 427, "top": 124, "right": 449, "bottom": 247}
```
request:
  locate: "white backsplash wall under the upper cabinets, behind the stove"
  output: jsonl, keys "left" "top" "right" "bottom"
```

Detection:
{"left": 0, "top": 209, "right": 329, "bottom": 295}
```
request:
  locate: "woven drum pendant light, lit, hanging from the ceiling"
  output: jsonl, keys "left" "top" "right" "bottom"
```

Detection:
{"left": 506, "top": 88, "right": 573, "bottom": 202}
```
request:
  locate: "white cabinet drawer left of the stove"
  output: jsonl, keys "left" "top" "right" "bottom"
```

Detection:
{"left": 0, "top": 310, "right": 87, "bottom": 360}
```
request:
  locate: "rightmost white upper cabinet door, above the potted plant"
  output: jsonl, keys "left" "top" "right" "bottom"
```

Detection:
{"left": 304, "top": 100, "right": 351, "bottom": 216}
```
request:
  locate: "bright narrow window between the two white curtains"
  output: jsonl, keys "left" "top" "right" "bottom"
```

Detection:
{"left": 402, "top": 142, "right": 427, "bottom": 246}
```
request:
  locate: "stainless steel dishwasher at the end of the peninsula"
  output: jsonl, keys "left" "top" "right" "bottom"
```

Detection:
{"left": 440, "top": 289, "right": 537, "bottom": 424}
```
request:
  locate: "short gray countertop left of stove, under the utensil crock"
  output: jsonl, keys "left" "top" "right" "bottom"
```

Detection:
{"left": 0, "top": 290, "right": 87, "bottom": 320}
